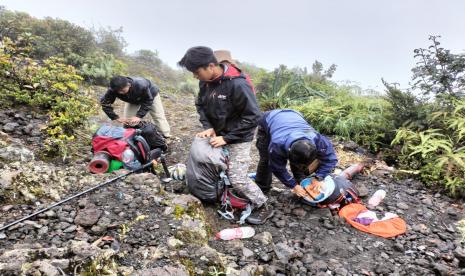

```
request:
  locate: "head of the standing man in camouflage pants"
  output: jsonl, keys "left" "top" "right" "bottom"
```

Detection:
{"left": 178, "top": 46, "right": 219, "bottom": 81}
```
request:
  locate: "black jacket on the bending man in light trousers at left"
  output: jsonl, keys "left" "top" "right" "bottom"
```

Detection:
{"left": 100, "top": 77, "right": 160, "bottom": 120}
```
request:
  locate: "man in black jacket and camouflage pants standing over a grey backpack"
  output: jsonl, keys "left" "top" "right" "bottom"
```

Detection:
{"left": 178, "top": 46, "right": 273, "bottom": 224}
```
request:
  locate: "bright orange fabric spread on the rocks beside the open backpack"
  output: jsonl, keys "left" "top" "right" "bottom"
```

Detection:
{"left": 339, "top": 203, "right": 407, "bottom": 238}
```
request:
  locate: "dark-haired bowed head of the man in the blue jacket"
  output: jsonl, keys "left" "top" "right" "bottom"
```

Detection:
{"left": 289, "top": 139, "right": 319, "bottom": 173}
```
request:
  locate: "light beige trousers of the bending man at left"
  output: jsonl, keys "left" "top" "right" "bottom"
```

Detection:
{"left": 124, "top": 93, "right": 171, "bottom": 137}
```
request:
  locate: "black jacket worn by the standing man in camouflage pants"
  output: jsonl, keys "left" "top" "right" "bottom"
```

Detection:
{"left": 195, "top": 65, "right": 261, "bottom": 144}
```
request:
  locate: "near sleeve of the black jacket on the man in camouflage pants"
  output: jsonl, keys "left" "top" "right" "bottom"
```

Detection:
{"left": 223, "top": 80, "right": 261, "bottom": 144}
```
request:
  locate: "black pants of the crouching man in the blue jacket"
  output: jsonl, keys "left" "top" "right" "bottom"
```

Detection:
{"left": 255, "top": 113, "right": 309, "bottom": 192}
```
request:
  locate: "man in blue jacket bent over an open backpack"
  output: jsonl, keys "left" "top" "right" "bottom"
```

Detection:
{"left": 255, "top": 109, "right": 338, "bottom": 197}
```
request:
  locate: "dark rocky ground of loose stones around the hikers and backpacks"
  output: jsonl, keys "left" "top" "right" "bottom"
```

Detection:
{"left": 0, "top": 91, "right": 465, "bottom": 275}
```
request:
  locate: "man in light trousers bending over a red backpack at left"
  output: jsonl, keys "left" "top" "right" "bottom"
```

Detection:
{"left": 100, "top": 76, "right": 171, "bottom": 138}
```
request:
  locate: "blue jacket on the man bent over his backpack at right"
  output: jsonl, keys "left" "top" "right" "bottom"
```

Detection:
{"left": 265, "top": 109, "right": 338, "bottom": 188}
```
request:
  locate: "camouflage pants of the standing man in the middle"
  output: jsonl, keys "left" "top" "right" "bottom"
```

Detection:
{"left": 226, "top": 142, "right": 268, "bottom": 207}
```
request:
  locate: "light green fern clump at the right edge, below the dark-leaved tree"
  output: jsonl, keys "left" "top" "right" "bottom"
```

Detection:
{"left": 392, "top": 100, "right": 465, "bottom": 196}
